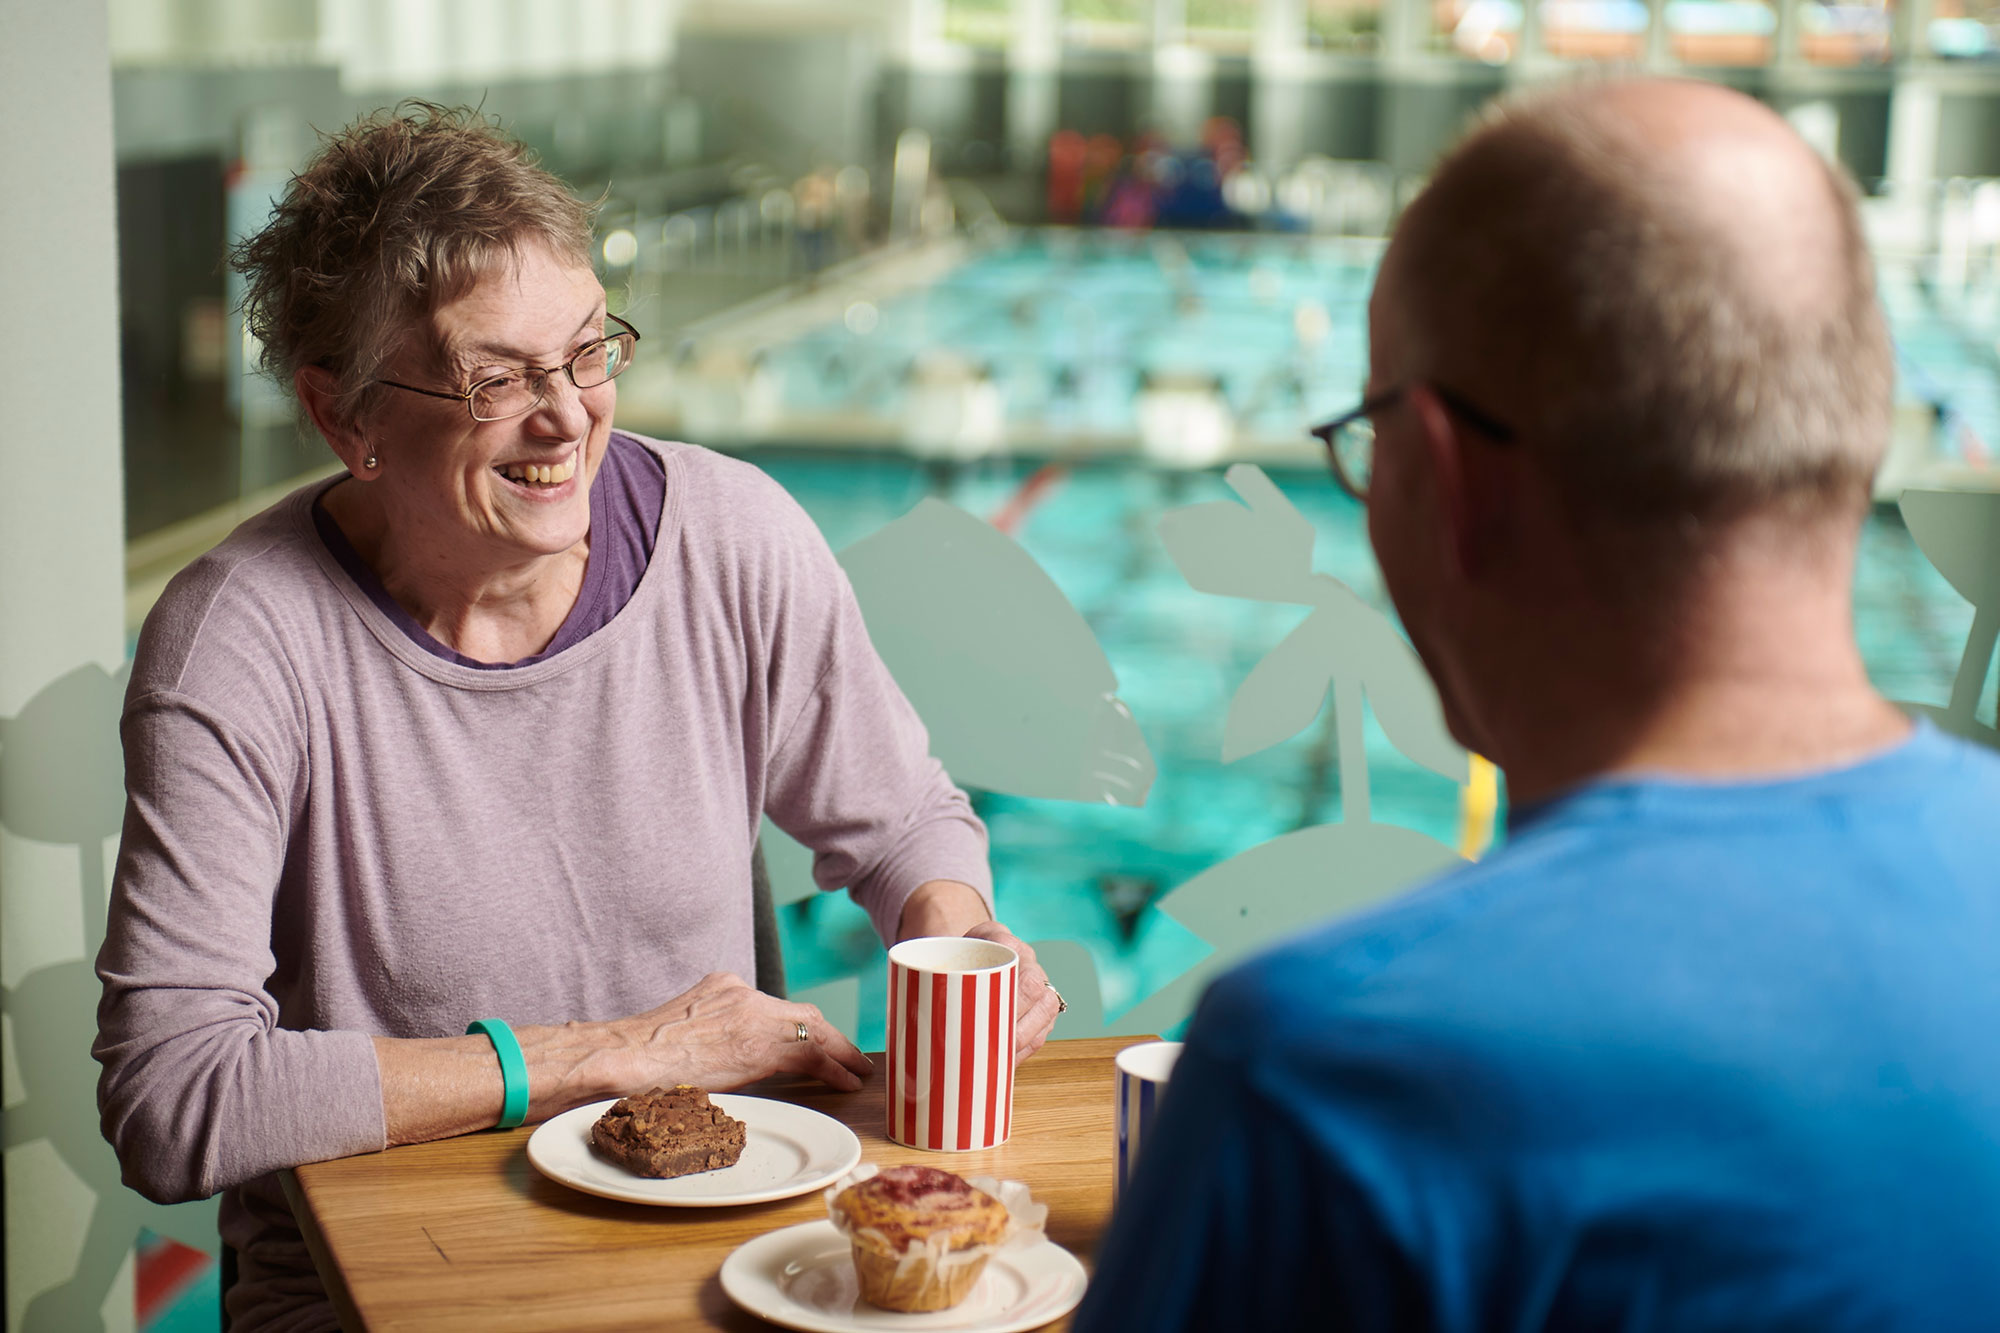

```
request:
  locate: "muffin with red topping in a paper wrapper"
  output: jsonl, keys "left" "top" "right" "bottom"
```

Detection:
{"left": 830, "top": 1167, "right": 1010, "bottom": 1313}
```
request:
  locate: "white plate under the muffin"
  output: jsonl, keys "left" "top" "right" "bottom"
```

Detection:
{"left": 722, "top": 1221, "right": 1088, "bottom": 1333}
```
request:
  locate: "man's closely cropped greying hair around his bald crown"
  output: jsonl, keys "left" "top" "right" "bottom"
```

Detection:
{"left": 1394, "top": 81, "right": 1894, "bottom": 532}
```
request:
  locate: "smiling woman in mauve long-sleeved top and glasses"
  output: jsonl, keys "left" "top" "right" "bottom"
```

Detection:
{"left": 96, "top": 104, "right": 1060, "bottom": 1331}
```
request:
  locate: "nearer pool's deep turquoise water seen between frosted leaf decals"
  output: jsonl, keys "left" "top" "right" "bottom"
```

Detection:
{"left": 750, "top": 452, "right": 1992, "bottom": 1049}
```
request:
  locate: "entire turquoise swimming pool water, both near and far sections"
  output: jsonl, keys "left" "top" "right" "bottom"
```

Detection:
{"left": 746, "top": 230, "right": 2000, "bottom": 1047}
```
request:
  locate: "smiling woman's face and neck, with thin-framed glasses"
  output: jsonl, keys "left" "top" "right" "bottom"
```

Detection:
{"left": 294, "top": 242, "right": 616, "bottom": 662}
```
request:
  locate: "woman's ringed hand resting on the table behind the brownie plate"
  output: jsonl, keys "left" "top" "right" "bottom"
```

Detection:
{"left": 608, "top": 973, "right": 874, "bottom": 1093}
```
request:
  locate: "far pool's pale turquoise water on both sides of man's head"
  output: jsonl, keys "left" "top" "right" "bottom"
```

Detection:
{"left": 770, "top": 228, "right": 2000, "bottom": 462}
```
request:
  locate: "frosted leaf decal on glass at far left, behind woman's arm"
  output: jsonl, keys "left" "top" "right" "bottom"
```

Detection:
{"left": 0, "top": 662, "right": 216, "bottom": 1333}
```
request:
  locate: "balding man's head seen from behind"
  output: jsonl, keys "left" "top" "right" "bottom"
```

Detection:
{"left": 1368, "top": 82, "right": 1894, "bottom": 745}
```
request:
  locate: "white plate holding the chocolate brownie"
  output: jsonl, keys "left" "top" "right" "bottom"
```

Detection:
{"left": 528, "top": 1093, "right": 862, "bottom": 1209}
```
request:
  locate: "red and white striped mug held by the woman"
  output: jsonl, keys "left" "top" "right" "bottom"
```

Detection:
{"left": 886, "top": 937, "right": 1020, "bottom": 1153}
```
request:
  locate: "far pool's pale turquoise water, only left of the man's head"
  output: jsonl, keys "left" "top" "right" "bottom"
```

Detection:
{"left": 774, "top": 230, "right": 1378, "bottom": 436}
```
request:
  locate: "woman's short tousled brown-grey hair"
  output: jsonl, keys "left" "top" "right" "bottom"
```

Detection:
{"left": 230, "top": 100, "right": 592, "bottom": 418}
